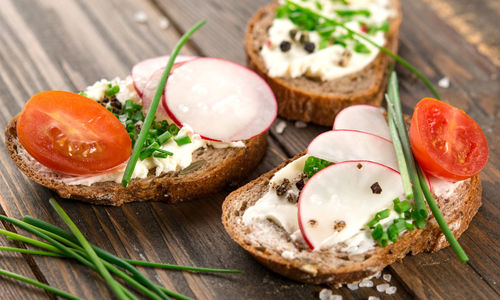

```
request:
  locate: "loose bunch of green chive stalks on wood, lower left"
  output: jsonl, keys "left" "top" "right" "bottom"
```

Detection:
{"left": 0, "top": 199, "right": 241, "bottom": 300}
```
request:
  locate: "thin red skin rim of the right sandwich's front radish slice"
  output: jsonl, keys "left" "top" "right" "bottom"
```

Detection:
{"left": 297, "top": 160, "right": 404, "bottom": 250}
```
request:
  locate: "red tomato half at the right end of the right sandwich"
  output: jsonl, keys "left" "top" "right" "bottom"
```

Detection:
{"left": 410, "top": 98, "right": 488, "bottom": 181}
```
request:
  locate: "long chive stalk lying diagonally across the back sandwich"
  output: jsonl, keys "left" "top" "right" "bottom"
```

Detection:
{"left": 286, "top": 0, "right": 441, "bottom": 100}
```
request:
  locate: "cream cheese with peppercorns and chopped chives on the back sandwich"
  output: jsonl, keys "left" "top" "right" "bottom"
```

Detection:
{"left": 260, "top": 0, "right": 397, "bottom": 81}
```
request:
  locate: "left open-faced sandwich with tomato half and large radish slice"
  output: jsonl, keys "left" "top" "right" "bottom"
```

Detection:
{"left": 5, "top": 57, "right": 276, "bottom": 205}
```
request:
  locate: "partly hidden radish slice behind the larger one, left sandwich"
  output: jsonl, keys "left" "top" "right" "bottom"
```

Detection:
{"left": 131, "top": 55, "right": 195, "bottom": 96}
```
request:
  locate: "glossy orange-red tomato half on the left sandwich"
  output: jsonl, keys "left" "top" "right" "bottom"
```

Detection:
{"left": 17, "top": 91, "right": 132, "bottom": 175}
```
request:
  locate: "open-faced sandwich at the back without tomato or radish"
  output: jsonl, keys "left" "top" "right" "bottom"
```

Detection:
{"left": 245, "top": 0, "right": 401, "bottom": 126}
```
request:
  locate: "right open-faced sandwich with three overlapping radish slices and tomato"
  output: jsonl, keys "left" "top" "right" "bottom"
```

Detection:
{"left": 222, "top": 75, "right": 488, "bottom": 286}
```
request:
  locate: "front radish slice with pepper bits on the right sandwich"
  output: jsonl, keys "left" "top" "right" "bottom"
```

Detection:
{"left": 298, "top": 161, "right": 404, "bottom": 250}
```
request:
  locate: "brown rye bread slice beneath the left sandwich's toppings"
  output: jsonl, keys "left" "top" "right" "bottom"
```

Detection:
{"left": 5, "top": 116, "right": 267, "bottom": 205}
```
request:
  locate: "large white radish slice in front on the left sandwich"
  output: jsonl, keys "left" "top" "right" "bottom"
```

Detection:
{"left": 165, "top": 57, "right": 277, "bottom": 142}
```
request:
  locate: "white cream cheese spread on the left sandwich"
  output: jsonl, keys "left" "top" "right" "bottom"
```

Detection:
{"left": 46, "top": 76, "right": 245, "bottom": 186}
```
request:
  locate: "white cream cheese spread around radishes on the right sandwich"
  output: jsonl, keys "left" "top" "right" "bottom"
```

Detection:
{"left": 242, "top": 155, "right": 465, "bottom": 255}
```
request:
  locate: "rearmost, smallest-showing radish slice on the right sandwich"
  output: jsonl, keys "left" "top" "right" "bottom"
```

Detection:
{"left": 333, "top": 104, "right": 392, "bottom": 140}
